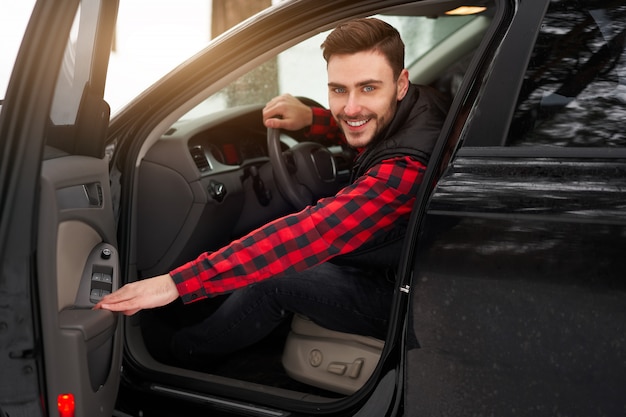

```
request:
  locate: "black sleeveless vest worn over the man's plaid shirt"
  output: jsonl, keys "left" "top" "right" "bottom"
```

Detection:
{"left": 331, "top": 84, "right": 448, "bottom": 272}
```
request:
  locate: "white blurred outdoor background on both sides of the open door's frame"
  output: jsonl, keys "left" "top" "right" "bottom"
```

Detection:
{"left": 0, "top": 0, "right": 288, "bottom": 115}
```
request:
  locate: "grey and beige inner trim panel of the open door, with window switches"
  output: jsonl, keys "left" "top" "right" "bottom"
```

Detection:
{"left": 37, "top": 155, "right": 121, "bottom": 416}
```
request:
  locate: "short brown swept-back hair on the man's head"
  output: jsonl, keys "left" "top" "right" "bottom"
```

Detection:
{"left": 322, "top": 18, "right": 404, "bottom": 78}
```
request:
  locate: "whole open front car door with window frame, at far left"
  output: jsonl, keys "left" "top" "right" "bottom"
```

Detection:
{"left": 0, "top": 0, "right": 122, "bottom": 417}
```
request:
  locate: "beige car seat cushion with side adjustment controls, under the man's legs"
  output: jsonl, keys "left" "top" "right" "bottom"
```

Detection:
{"left": 282, "top": 315, "right": 384, "bottom": 394}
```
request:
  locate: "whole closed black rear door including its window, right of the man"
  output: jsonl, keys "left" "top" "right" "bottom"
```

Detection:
{"left": 406, "top": 0, "right": 626, "bottom": 416}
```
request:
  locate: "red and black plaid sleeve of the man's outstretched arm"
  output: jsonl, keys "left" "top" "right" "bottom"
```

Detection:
{"left": 170, "top": 157, "right": 425, "bottom": 303}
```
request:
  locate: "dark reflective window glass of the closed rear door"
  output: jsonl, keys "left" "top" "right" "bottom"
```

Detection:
{"left": 507, "top": 1, "right": 626, "bottom": 147}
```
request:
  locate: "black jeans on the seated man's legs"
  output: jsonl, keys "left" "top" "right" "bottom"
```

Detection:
{"left": 172, "top": 263, "right": 393, "bottom": 362}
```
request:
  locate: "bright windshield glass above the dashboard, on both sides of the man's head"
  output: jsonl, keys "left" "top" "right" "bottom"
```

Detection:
{"left": 181, "top": 15, "right": 475, "bottom": 120}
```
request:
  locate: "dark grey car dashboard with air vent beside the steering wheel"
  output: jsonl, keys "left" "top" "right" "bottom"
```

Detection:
{"left": 137, "top": 101, "right": 334, "bottom": 276}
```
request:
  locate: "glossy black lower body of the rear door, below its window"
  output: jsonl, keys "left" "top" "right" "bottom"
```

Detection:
{"left": 407, "top": 154, "right": 626, "bottom": 416}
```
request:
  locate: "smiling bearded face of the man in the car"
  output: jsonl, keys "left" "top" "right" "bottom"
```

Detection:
{"left": 327, "top": 51, "right": 409, "bottom": 148}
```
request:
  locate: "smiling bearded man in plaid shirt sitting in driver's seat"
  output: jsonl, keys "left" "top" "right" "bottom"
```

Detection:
{"left": 95, "top": 19, "right": 446, "bottom": 362}
